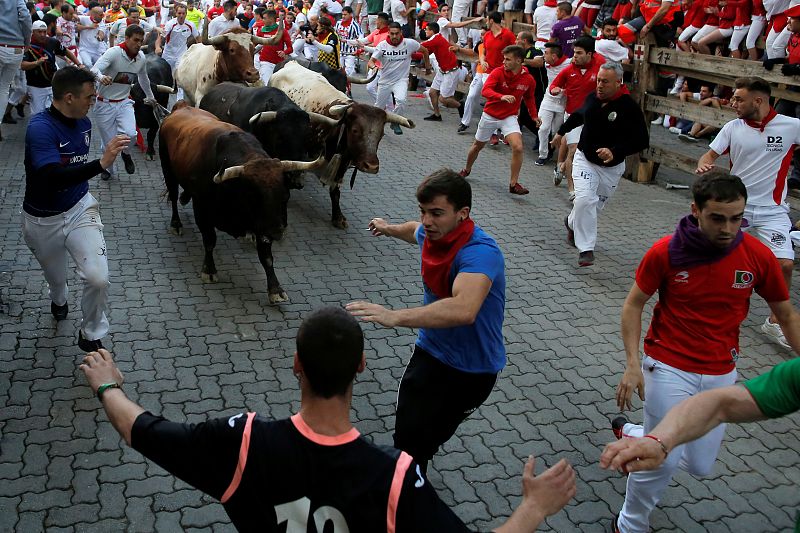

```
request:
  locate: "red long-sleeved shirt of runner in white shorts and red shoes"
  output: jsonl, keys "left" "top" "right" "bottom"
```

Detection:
{"left": 481, "top": 67, "right": 539, "bottom": 119}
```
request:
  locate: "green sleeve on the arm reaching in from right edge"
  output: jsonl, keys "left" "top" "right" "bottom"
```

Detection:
{"left": 744, "top": 358, "right": 800, "bottom": 418}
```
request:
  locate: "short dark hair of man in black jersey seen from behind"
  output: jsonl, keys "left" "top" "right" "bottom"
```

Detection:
{"left": 296, "top": 306, "right": 364, "bottom": 398}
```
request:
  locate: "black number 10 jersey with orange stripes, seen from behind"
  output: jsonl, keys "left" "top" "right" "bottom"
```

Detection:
{"left": 131, "top": 412, "right": 476, "bottom": 533}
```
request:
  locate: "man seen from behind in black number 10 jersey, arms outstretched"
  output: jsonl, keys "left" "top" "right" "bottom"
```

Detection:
{"left": 81, "top": 307, "right": 575, "bottom": 533}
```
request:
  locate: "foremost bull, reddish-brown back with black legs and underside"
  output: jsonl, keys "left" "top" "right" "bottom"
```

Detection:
{"left": 158, "top": 102, "right": 323, "bottom": 303}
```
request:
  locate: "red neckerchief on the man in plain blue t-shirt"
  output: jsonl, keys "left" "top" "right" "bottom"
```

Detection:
{"left": 422, "top": 218, "right": 475, "bottom": 299}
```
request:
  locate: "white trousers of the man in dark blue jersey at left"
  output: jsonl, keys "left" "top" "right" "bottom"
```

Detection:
{"left": 22, "top": 193, "right": 109, "bottom": 341}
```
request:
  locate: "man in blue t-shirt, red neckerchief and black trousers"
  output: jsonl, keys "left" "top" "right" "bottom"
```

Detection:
{"left": 347, "top": 169, "right": 506, "bottom": 469}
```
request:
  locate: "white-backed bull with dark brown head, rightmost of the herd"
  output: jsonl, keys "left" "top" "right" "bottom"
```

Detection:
{"left": 269, "top": 62, "right": 414, "bottom": 228}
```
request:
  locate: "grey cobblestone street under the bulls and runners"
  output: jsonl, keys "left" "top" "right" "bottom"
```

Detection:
{"left": 0, "top": 86, "right": 800, "bottom": 533}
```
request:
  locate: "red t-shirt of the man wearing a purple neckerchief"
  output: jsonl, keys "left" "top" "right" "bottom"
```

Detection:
{"left": 636, "top": 234, "right": 789, "bottom": 375}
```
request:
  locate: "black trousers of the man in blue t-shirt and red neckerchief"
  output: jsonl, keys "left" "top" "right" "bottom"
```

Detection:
{"left": 394, "top": 346, "right": 497, "bottom": 470}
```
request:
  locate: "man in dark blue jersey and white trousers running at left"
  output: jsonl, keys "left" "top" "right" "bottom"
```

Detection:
{"left": 22, "top": 66, "right": 130, "bottom": 351}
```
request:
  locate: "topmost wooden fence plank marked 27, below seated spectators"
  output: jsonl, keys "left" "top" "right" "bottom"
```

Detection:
{"left": 649, "top": 48, "right": 798, "bottom": 87}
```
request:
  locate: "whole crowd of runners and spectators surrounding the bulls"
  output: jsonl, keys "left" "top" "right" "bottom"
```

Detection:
{"left": 0, "top": 0, "right": 800, "bottom": 533}
